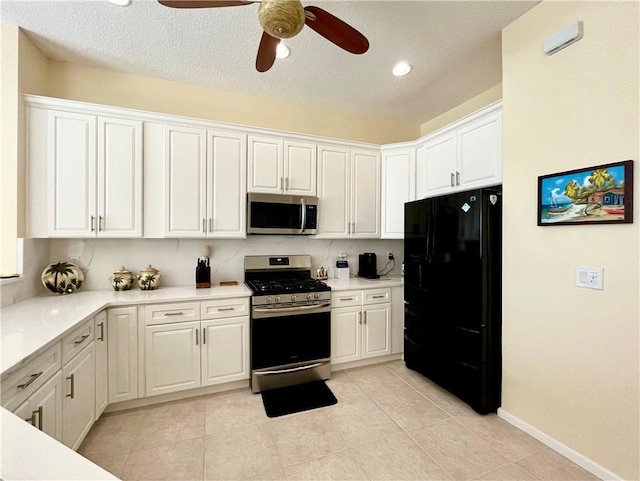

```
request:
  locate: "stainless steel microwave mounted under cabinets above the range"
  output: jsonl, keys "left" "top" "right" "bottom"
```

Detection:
{"left": 247, "top": 193, "right": 318, "bottom": 235}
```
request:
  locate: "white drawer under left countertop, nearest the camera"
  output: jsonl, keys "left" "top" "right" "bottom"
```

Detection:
{"left": 0, "top": 342, "right": 62, "bottom": 411}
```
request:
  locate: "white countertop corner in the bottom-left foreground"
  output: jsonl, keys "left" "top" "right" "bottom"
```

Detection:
{"left": 0, "top": 408, "right": 118, "bottom": 481}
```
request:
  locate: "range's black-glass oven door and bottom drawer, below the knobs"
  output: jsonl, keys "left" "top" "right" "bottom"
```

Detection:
{"left": 251, "top": 302, "right": 331, "bottom": 392}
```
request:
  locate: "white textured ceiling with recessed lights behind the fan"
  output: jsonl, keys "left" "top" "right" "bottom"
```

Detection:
{"left": 0, "top": 0, "right": 539, "bottom": 124}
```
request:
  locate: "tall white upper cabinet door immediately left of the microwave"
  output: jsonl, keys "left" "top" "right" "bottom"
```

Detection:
{"left": 207, "top": 132, "right": 247, "bottom": 238}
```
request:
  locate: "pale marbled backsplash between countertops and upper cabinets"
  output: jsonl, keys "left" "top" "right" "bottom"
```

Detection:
{"left": 37, "top": 235, "right": 403, "bottom": 290}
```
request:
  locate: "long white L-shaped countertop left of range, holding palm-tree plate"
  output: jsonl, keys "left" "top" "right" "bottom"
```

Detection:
{"left": 0, "top": 284, "right": 251, "bottom": 373}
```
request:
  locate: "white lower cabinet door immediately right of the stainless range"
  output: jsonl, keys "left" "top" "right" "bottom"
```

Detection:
{"left": 331, "top": 306, "right": 362, "bottom": 364}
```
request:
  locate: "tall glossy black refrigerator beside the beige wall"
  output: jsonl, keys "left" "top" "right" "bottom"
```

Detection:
{"left": 404, "top": 186, "right": 502, "bottom": 414}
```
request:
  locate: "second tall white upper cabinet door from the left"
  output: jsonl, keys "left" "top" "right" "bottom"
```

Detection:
{"left": 96, "top": 117, "right": 142, "bottom": 237}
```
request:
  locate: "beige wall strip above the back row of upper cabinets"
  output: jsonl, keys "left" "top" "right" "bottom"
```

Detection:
{"left": 43, "top": 62, "right": 419, "bottom": 144}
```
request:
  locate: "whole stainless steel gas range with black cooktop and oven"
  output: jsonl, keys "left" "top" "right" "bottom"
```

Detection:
{"left": 244, "top": 255, "right": 331, "bottom": 393}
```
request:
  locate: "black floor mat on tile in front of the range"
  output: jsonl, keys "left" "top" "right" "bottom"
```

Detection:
{"left": 261, "top": 381, "right": 338, "bottom": 418}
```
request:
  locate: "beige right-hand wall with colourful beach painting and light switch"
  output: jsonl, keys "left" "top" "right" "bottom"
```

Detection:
{"left": 502, "top": 1, "right": 640, "bottom": 479}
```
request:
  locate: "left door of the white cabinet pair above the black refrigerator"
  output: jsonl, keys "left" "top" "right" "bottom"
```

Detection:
{"left": 424, "top": 132, "right": 459, "bottom": 197}
